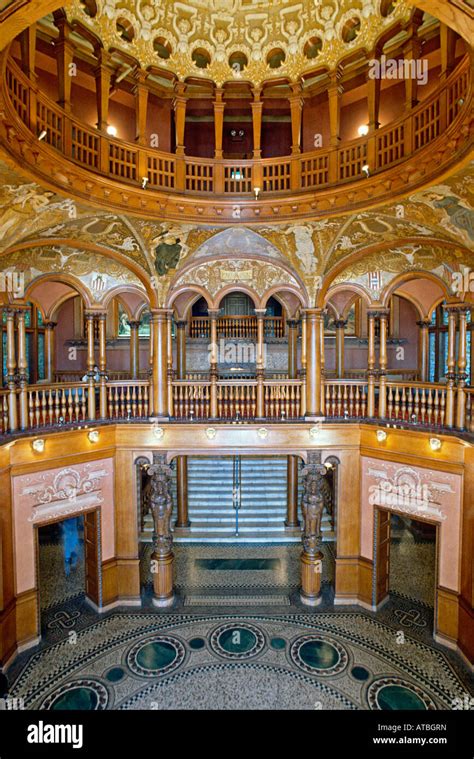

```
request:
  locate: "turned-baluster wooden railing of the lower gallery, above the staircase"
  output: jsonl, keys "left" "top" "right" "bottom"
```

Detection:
{"left": 0, "top": 375, "right": 474, "bottom": 434}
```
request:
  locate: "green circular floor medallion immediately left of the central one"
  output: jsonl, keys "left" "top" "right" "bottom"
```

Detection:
{"left": 127, "top": 635, "right": 185, "bottom": 677}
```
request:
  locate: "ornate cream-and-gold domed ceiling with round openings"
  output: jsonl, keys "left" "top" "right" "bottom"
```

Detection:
{"left": 65, "top": 0, "right": 413, "bottom": 85}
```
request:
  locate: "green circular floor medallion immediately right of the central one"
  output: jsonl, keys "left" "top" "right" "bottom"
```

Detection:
{"left": 290, "top": 635, "right": 349, "bottom": 677}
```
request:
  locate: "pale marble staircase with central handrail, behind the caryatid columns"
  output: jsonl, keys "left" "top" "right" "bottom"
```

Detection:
{"left": 142, "top": 456, "right": 333, "bottom": 543}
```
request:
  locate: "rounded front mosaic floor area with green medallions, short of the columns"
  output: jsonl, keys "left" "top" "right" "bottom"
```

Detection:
{"left": 10, "top": 612, "right": 472, "bottom": 710}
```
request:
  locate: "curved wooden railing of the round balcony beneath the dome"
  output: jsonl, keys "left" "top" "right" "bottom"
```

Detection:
{"left": 2, "top": 55, "right": 470, "bottom": 198}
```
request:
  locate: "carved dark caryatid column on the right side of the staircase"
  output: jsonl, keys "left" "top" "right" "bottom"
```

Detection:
{"left": 300, "top": 451, "right": 326, "bottom": 606}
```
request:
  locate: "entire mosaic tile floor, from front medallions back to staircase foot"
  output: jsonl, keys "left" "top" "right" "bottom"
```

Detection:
{"left": 8, "top": 538, "right": 474, "bottom": 710}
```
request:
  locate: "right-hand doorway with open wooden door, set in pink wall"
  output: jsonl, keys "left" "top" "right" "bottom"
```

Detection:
{"left": 374, "top": 509, "right": 438, "bottom": 619}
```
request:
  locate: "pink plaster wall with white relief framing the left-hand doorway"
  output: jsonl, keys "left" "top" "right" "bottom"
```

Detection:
{"left": 12, "top": 458, "right": 115, "bottom": 594}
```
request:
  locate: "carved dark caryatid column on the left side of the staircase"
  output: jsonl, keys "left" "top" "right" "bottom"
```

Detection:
{"left": 147, "top": 454, "right": 174, "bottom": 607}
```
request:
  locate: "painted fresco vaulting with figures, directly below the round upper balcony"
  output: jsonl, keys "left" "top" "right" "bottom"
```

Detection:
{"left": 0, "top": 159, "right": 474, "bottom": 303}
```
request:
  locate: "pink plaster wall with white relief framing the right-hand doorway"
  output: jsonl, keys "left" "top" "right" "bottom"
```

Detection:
{"left": 361, "top": 457, "right": 462, "bottom": 592}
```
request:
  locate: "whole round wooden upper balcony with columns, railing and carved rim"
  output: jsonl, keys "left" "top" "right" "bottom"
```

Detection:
{"left": 0, "top": 12, "right": 472, "bottom": 224}
